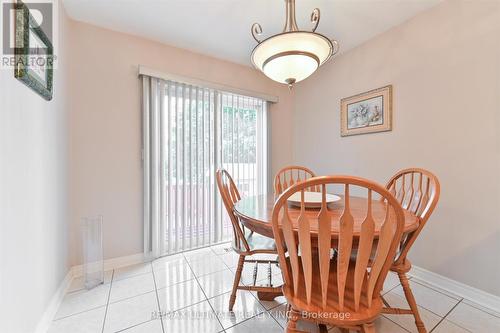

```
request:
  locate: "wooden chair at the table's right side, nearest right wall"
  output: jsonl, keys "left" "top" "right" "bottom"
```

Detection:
{"left": 384, "top": 168, "right": 440, "bottom": 333}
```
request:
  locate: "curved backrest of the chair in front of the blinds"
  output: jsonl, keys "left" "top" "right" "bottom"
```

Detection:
{"left": 216, "top": 169, "right": 250, "bottom": 253}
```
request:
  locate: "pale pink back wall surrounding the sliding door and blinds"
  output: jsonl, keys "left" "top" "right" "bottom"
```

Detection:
{"left": 70, "top": 21, "right": 292, "bottom": 265}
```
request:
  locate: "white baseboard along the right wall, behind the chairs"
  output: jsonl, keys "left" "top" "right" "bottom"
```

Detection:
{"left": 409, "top": 266, "right": 500, "bottom": 313}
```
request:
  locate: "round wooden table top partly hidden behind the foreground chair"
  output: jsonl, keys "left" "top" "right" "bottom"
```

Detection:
{"left": 234, "top": 194, "right": 419, "bottom": 238}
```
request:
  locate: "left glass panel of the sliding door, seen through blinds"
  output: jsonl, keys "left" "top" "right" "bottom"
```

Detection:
{"left": 160, "top": 82, "right": 216, "bottom": 253}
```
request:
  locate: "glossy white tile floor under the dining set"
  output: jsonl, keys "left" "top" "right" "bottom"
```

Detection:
{"left": 49, "top": 244, "right": 500, "bottom": 333}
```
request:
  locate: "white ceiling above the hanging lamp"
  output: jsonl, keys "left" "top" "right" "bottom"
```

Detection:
{"left": 63, "top": 0, "right": 441, "bottom": 66}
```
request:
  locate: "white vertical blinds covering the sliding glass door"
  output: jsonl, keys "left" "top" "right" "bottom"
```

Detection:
{"left": 142, "top": 76, "right": 267, "bottom": 257}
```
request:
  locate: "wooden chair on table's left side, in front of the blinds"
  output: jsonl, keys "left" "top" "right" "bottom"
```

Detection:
{"left": 216, "top": 169, "right": 281, "bottom": 311}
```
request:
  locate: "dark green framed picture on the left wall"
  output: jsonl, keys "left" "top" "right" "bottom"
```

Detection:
{"left": 14, "top": 1, "right": 54, "bottom": 101}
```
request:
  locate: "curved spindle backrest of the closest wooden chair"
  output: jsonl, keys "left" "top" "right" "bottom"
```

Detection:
{"left": 272, "top": 176, "right": 405, "bottom": 311}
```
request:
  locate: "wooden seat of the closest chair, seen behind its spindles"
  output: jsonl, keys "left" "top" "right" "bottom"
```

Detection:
{"left": 283, "top": 258, "right": 383, "bottom": 326}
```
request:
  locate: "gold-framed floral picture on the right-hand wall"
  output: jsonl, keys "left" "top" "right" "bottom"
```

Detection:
{"left": 340, "top": 85, "right": 392, "bottom": 136}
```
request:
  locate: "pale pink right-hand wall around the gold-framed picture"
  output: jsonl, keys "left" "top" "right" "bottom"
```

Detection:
{"left": 293, "top": 0, "right": 500, "bottom": 295}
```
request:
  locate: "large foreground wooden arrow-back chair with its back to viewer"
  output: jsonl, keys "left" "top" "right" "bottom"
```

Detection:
{"left": 272, "top": 176, "right": 405, "bottom": 333}
